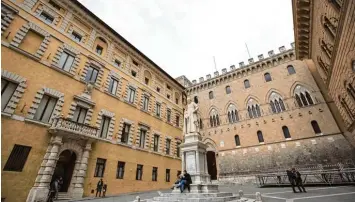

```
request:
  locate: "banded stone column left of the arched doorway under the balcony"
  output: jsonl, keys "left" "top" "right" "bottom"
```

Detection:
{"left": 26, "top": 136, "right": 62, "bottom": 202}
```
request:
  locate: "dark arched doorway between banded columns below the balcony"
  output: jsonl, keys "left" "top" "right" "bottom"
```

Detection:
{"left": 52, "top": 150, "right": 76, "bottom": 192}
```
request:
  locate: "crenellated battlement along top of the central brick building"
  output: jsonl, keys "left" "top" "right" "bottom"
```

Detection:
{"left": 188, "top": 42, "right": 295, "bottom": 88}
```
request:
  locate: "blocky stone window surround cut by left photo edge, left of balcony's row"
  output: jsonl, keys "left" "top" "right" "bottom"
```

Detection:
{"left": 1, "top": 69, "right": 27, "bottom": 114}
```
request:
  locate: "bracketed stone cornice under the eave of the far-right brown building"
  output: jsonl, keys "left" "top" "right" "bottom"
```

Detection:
{"left": 292, "top": 0, "right": 312, "bottom": 60}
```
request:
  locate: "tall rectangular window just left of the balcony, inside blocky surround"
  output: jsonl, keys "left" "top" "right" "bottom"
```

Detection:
{"left": 34, "top": 95, "right": 58, "bottom": 123}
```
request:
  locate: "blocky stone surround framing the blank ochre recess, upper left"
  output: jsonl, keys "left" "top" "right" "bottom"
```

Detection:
{"left": 11, "top": 22, "right": 51, "bottom": 58}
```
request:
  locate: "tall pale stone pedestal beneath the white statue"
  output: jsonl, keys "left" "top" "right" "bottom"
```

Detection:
{"left": 180, "top": 132, "right": 214, "bottom": 193}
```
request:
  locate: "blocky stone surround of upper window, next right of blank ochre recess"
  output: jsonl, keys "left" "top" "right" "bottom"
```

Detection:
{"left": 52, "top": 43, "right": 80, "bottom": 76}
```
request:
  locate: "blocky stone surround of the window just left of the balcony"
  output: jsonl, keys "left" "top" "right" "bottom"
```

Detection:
{"left": 27, "top": 87, "right": 64, "bottom": 123}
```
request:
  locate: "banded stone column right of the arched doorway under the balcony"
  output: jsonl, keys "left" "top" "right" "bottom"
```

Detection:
{"left": 72, "top": 141, "right": 92, "bottom": 199}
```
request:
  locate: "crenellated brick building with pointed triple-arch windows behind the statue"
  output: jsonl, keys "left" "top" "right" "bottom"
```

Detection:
{"left": 182, "top": 43, "right": 355, "bottom": 179}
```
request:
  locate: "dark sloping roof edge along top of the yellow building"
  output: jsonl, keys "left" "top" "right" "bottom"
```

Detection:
{"left": 71, "top": 0, "right": 185, "bottom": 89}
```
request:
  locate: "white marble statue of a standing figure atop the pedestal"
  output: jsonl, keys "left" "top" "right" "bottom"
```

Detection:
{"left": 184, "top": 98, "right": 200, "bottom": 134}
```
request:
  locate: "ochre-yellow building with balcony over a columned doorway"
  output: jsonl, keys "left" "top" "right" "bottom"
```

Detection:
{"left": 1, "top": 0, "right": 186, "bottom": 202}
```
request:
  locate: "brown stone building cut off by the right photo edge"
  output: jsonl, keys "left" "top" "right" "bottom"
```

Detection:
{"left": 292, "top": 0, "right": 355, "bottom": 146}
